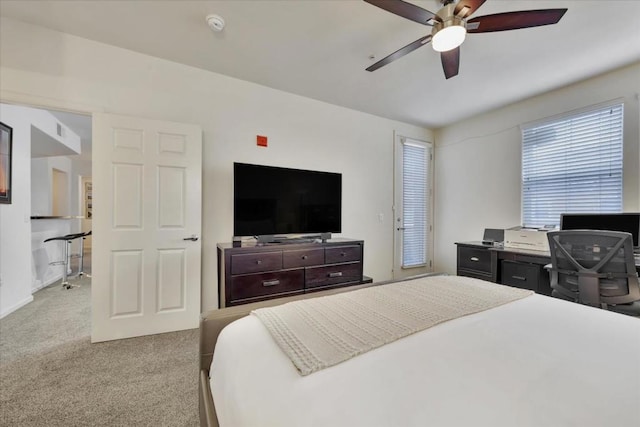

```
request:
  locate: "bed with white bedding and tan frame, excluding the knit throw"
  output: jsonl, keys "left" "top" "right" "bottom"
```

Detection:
{"left": 200, "top": 276, "right": 640, "bottom": 427}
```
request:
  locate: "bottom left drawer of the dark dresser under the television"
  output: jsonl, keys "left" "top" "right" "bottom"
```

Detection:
{"left": 230, "top": 269, "right": 304, "bottom": 302}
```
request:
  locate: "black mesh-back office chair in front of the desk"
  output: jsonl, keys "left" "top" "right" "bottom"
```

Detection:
{"left": 547, "top": 230, "right": 640, "bottom": 316}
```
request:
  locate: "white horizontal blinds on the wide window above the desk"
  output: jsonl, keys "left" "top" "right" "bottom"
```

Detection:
{"left": 522, "top": 104, "right": 623, "bottom": 227}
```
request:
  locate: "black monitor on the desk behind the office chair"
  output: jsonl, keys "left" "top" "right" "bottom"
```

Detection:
{"left": 560, "top": 213, "right": 640, "bottom": 248}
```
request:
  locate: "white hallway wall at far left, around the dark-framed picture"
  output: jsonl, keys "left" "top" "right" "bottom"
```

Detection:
{"left": 0, "top": 103, "right": 33, "bottom": 318}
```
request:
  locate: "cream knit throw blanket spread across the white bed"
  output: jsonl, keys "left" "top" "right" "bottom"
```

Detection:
{"left": 251, "top": 276, "right": 533, "bottom": 375}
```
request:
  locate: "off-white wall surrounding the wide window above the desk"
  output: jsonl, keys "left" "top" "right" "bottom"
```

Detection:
{"left": 434, "top": 63, "right": 640, "bottom": 273}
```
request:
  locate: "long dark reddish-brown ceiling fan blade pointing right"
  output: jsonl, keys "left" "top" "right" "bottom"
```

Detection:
{"left": 467, "top": 9, "right": 567, "bottom": 33}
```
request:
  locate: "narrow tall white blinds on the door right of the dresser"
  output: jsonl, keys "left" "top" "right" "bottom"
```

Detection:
{"left": 402, "top": 141, "right": 431, "bottom": 267}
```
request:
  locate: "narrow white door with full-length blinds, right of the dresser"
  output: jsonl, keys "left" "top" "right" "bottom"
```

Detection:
{"left": 393, "top": 136, "right": 433, "bottom": 279}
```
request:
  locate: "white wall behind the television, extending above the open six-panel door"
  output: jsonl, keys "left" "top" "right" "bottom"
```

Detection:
{"left": 0, "top": 18, "right": 432, "bottom": 309}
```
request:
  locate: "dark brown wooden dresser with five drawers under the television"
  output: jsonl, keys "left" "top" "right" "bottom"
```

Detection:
{"left": 218, "top": 238, "right": 372, "bottom": 308}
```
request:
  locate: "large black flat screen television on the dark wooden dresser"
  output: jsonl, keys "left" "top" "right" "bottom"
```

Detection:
{"left": 233, "top": 163, "right": 342, "bottom": 236}
